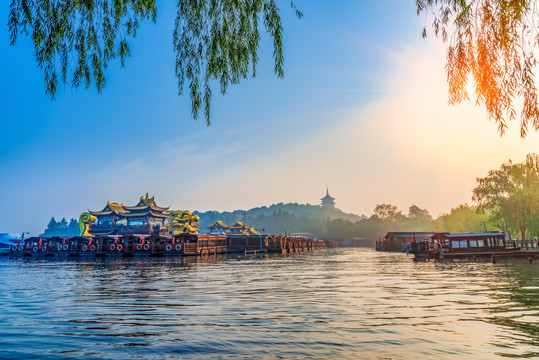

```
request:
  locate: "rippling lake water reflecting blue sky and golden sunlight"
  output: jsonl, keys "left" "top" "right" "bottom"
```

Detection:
{"left": 0, "top": 248, "right": 539, "bottom": 359}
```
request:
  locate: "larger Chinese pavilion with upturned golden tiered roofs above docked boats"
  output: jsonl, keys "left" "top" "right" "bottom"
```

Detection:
{"left": 88, "top": 193, "right": 170, "bottom": 235}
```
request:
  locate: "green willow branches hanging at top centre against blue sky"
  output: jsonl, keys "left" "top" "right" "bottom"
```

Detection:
{"left": 173, "top": 0, "right": 302, "bottom": 124}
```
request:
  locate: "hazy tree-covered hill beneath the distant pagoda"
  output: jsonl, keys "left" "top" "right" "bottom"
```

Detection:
{"left": 195, "top": 203, "right": 365, "bottom": 232}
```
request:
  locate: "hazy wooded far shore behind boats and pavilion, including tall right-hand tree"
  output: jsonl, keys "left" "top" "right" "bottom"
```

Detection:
{"left": 41, "top": 154, "right": 539, "bottom": 243}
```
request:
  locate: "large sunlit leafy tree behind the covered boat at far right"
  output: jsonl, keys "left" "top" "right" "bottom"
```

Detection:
{"left": 473, "top": 154, "right": 539, "bottom": 239}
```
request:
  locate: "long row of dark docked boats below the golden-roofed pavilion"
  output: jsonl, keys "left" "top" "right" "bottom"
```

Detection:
{"left": 9, "top": 233, "right": 326, "bottom": 257}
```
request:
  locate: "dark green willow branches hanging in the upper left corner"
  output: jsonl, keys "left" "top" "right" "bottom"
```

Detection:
{"left": 8, "top": 0, "right": 157, "bottom": 99}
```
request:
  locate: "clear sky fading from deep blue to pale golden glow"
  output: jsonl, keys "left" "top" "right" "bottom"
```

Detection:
{"left": 0, "top": 0, "right": 538, "bottom": 233}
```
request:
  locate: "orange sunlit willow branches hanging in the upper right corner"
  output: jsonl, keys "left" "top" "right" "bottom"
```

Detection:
{"left": 416, "top": 0, "right": 539, "bottom": 138}
